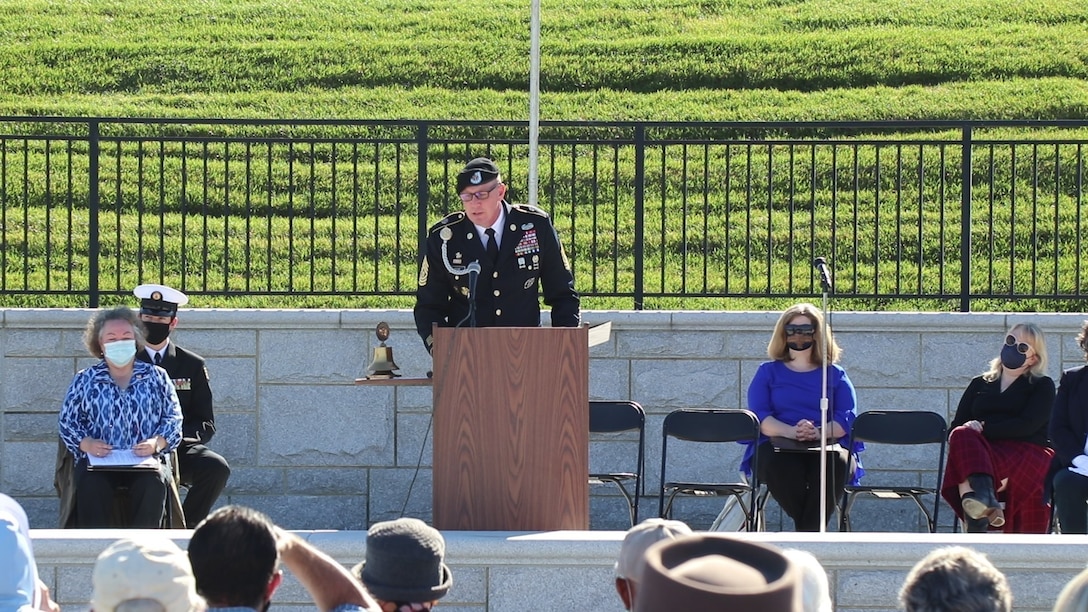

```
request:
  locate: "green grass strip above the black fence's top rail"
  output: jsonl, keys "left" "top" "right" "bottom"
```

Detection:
{"left": 0, "top": 0, "right": 1088, "bottom": 120}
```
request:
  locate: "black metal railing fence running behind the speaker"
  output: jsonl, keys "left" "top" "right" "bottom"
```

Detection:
{"left": 0, "top": 118, "right": 1088, "bottom": 310}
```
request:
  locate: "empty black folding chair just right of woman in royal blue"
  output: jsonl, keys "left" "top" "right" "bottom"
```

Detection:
{"left": 839, "top": 411, "right": 948, "bottom": 534}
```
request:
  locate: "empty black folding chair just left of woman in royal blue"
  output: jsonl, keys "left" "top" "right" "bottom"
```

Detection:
{"left": 657, "top": 409, "right": 759, "bottom": 531}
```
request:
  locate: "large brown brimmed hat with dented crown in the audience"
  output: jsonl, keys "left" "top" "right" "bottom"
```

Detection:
{"left": 634, "top": 534, "right": 802, "bottom": 612}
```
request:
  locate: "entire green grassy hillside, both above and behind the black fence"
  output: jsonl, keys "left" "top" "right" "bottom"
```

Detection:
{"left": 0, "top": 0, "right": 1088, "bottom": 310}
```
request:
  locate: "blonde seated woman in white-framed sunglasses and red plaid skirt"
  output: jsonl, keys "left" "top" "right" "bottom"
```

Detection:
{"left": 941, "top": 323, "right": 1054, "bottom": 534}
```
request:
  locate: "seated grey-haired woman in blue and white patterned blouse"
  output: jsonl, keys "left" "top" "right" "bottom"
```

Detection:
{"left": 60, "top": 306, "right": 182, "bottom": 528}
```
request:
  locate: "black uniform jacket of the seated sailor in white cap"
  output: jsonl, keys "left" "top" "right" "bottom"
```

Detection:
{"left": 136, "top": 341, "right": 215, "bottom": 446}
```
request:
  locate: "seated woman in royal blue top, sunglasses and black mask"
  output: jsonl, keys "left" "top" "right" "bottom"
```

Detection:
{"left": 741, "top": 304, "right": 862, "bottom": 531}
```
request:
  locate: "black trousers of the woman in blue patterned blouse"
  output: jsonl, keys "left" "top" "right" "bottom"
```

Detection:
{"left": 75, "top": 457, "right": 169, "bottom": 529}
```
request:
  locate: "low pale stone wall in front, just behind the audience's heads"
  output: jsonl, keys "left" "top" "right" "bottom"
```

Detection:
{"left": 32, "top": 529, "right": 1088, "bottom": 612}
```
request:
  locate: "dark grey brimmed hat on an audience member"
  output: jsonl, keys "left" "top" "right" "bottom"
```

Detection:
{"left": 351, "top": 518, "right": 454, "bottom": 603}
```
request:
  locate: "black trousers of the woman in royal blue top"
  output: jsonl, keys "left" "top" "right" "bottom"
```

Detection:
{"left": 756, "top": 442, "right": 853, "bottom": 531}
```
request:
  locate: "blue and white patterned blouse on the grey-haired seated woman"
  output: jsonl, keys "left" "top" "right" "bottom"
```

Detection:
{"left": 59, "top": 359, "right": 182, "bottom": 461}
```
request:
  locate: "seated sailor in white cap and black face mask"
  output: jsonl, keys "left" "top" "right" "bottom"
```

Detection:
{"left": 133, "top": 284, "right": 231, "bottom": 529}
